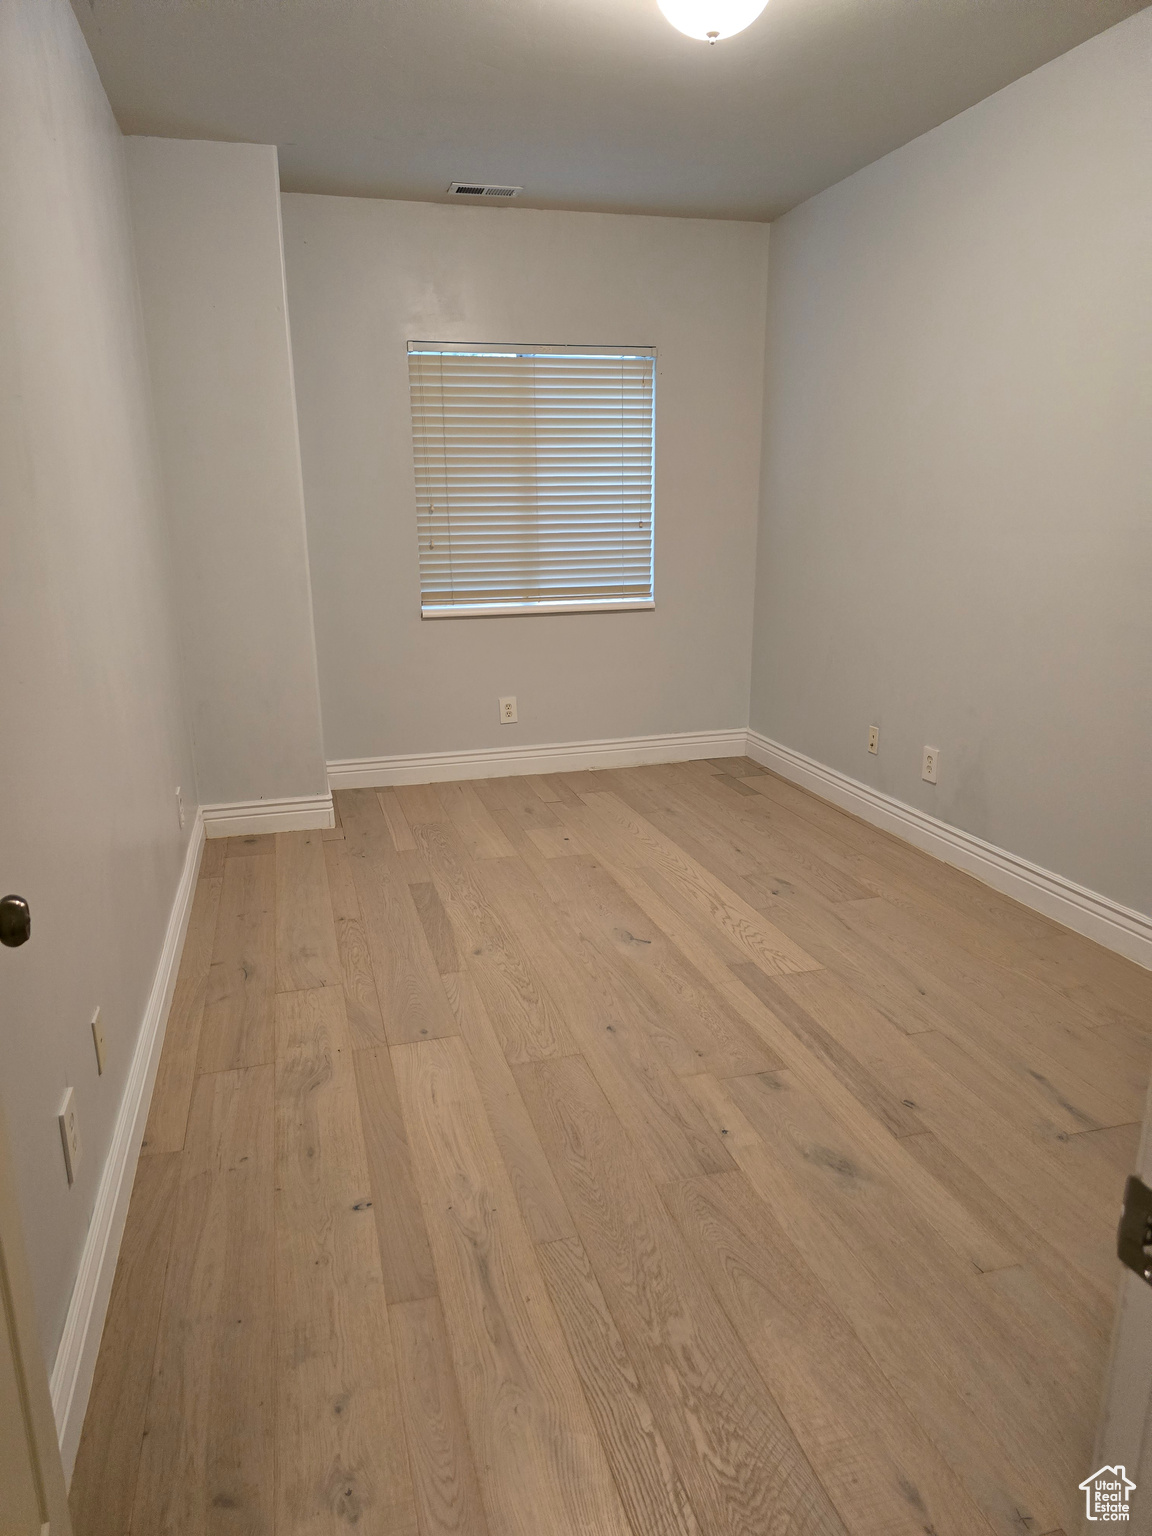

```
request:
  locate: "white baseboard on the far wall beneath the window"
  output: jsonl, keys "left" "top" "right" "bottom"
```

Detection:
{"left": 329, "top": 727, "right": 748, "bottom": 790}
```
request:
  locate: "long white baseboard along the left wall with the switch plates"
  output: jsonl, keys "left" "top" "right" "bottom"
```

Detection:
{"left": 51, "top": 811, "right": 204, "bottom": 1482}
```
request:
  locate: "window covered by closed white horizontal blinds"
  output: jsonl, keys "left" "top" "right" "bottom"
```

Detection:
{"left": 409, "top": 341, "right": 656, "bottom": 619}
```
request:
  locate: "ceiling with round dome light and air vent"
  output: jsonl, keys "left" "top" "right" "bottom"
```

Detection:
{"left": 74, "top": 0, "right": 1144, "bottom": 220}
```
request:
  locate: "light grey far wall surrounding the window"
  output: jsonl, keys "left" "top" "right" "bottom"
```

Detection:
{"left": 284, "top": 195, "right": 768, "bottom": 759}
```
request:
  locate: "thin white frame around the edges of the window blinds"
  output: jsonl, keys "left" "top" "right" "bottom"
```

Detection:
{"left": 406, "top": 339, "right": 657, "bottom": 621}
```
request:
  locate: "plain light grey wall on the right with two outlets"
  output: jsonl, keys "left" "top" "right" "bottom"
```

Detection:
{"left": 751, "top": 11, "right": 1152, "bottom": 912}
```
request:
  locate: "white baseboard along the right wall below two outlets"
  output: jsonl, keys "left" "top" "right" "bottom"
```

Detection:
{"left": 746, "top": 731, "right": 1152, "bottom": 969}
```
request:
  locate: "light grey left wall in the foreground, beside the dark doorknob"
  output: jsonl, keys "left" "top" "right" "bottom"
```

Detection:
{"left": 0, "top": 0, "right": 195, "bottom": 1366}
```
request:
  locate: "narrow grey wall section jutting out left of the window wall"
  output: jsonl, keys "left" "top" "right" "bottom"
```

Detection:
{"left": 126, "top": 138, "right": 327, "bottom": 805}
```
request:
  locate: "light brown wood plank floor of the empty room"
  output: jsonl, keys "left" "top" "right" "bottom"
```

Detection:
{"left": 71, "top": 759, "right": 1152, "bottom": 1536}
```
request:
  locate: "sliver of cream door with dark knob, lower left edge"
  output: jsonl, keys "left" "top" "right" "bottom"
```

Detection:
{"left": 0, "top": 897, "right": 72, "bottom": 1536}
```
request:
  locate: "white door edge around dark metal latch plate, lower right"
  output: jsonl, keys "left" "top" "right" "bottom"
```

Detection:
{"left": 1083, "top": 1084, "right": 1152, "bottom": 1536}
